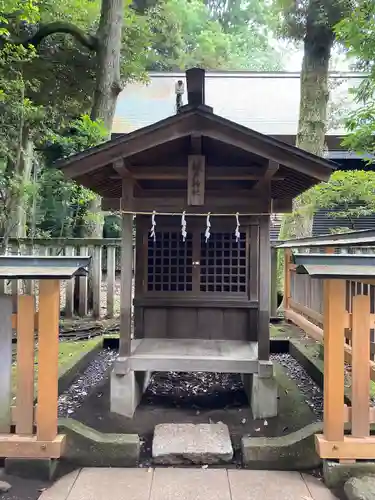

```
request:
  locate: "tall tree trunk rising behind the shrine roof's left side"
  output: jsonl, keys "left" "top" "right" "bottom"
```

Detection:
{"left": 85, "top": 0, "right": 124, "bottom": 238}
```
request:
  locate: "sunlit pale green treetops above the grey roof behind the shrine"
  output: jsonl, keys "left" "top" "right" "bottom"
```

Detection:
{"left": 148, "top": 0, "right": 281, "bottom": 71}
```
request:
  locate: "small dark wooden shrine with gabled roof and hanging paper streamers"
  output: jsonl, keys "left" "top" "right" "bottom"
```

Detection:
{"left": 58, "top": 68, "right": 334, "bottom": 418}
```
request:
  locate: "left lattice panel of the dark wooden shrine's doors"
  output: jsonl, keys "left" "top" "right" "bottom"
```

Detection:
{"left": 147, "top": 231, "right": 193, "bottom": 292}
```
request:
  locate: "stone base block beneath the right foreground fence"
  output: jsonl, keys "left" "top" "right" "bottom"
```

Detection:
{"left": 323, "top": 460, "right": 375, "bottom": 488}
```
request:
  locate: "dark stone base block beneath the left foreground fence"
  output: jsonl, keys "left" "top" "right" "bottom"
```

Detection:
{"left": 4, "top": 458, "right": 58, "bottom": 481}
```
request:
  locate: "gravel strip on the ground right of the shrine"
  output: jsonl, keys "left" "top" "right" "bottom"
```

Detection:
{"left": 271, "top": 354, "right": 323, "bottom": 420}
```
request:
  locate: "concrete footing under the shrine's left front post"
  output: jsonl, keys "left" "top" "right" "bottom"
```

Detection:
{"left": 110, "top": 370, "right": 151, "bottom": 418}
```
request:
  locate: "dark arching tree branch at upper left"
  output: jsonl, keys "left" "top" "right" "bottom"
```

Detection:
{"left": 8, "top": 21, "right": 98, "bottom": 51}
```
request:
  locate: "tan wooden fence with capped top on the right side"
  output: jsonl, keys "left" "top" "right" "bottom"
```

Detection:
{"left": 284, "top": 234, "right": 375, "bottom": 463}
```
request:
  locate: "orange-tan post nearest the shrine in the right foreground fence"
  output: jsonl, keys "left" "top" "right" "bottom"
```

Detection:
{"left": 323, "top": 279, "right": 346, "bottom": 441}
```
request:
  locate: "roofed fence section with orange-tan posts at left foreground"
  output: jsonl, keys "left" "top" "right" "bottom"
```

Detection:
{"left": 0, "top": 255, "right": 90, "bottom": 459}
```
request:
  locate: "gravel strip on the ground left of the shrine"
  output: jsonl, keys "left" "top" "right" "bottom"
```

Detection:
{"left": 58, "top": 349, "right": 117, "bottom": 417}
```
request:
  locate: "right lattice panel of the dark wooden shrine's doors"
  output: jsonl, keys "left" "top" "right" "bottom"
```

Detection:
{"left": 200, "top": 233, "right": 247, "bottom": 293}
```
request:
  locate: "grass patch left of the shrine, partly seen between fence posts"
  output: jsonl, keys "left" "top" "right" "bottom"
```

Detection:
{"left": 12, "top": 337, "right": 102, "bottom": 397}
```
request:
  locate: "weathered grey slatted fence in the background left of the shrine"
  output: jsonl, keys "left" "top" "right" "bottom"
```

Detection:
{"left": 0, "top": 238, "right": 121, "bottom": 318}
